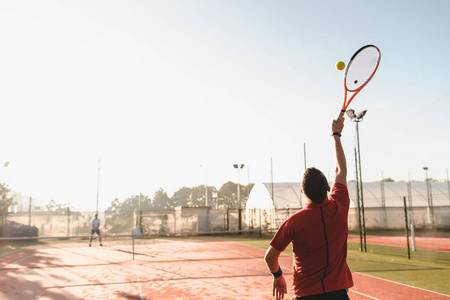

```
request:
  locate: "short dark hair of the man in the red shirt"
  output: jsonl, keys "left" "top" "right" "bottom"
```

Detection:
{"left": 302, "top": 168, "right": 330, "bottom": 203}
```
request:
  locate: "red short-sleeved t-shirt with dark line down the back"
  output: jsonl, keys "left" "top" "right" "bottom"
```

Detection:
{"left": 270, "top": 183, "right": 353, "bottom": 297}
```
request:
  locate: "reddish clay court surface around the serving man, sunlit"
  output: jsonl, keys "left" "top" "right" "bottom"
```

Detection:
{"left": 0, "top": 237, "right": 450, "bottom": 300}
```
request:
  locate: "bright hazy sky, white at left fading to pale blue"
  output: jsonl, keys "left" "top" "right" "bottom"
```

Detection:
{"left": 0, "top": 0, "right": 450, "bottom": 210}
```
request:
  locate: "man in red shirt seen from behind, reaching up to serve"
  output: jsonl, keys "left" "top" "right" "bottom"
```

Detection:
{"left": 264, "top": 120, "right": 353, "bottom": 300}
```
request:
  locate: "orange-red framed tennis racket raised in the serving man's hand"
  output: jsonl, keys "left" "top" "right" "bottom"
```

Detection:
{"left": 337, "top": 45, "right": 381, "bottom": 122}
